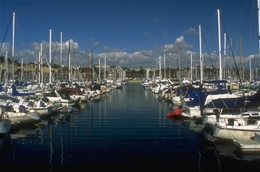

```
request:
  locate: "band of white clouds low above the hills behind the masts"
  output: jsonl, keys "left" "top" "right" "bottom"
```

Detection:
{"left": 0, "top": 32, "right": 255, "bottom": 67}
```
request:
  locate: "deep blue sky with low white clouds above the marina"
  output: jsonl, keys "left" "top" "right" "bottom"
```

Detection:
{"left": 0, "top": 0, "right": 258, "bottom": 68}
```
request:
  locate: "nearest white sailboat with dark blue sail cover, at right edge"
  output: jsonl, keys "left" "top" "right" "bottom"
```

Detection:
{"left": 204, "top": 4, "right": 260, "bottom": 142}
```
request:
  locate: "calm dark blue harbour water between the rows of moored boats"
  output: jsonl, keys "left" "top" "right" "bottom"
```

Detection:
{"left": 0, "top": 84, "right": 259, "bottom": 171}
